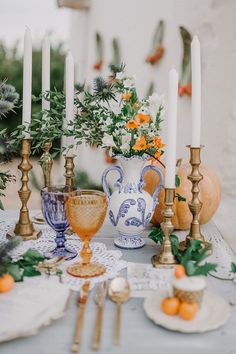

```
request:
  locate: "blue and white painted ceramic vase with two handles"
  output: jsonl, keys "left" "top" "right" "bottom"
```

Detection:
{"left": 102, "top": 155, "right": 163, "bottom": 249}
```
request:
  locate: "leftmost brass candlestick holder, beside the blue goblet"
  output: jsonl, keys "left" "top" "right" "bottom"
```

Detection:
{"left": 7, "top": 138, "right": 41, "bottom": 240}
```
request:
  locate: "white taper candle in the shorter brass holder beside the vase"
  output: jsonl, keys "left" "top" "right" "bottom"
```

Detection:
{"left": 165, "top": 69, "right": 178, "bottom": 188}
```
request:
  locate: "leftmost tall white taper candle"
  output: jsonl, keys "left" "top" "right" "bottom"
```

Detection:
{"left": 22, "top": 27, "right": 32, "bottom": 137}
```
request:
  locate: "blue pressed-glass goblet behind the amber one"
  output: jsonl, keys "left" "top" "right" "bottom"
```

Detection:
{"left": 41, "top": 186, "right": 77, "bottom": 260}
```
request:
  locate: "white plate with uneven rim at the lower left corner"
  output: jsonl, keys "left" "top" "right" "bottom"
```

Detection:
{"left": 0, "top": 276, "right": 70, "bottom": 342}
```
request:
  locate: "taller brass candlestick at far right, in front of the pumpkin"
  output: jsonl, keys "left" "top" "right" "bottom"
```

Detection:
{"left": 181, "top": 145, "right": 211, "bottom": 249}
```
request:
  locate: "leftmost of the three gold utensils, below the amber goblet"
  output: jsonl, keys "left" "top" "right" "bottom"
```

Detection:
{"left": 71, "top": 281, "right": 90, "bottom": 353}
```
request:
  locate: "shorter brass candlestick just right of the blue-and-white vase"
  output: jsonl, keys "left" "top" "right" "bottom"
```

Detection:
{"left": 151, "top": 188, "right": 177, "bottom": 267}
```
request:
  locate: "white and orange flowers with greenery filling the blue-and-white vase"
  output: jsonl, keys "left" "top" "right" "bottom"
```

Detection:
{"left": 74, "top": 66, "right": 165, "bottom": 159}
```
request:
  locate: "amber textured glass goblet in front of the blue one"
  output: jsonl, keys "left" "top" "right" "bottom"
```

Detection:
{"left": 66, "top": 189, "right": 107, "bottom": 278}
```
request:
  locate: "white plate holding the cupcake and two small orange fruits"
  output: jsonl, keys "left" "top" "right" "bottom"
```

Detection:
{"left": 144, "top": 291, "right": 230, "bottom": 333}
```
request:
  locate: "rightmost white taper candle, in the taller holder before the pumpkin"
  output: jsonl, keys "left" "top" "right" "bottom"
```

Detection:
{"left": 191, "top": 36, "right": 201, "bottom": 147}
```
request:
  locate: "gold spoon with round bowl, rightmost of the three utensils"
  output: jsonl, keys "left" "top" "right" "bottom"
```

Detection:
{"left": 108, "top": 278, "right": 130, "bottom": 345}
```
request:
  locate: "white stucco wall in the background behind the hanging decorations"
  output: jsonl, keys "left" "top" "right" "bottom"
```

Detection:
{"left": 71, "top": 0, "right": 236, "bottom": 249}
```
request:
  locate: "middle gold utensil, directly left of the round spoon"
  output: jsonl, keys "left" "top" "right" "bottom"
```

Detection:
{"left": 91, "top": 281, "right": 107, "bottom": 350}
